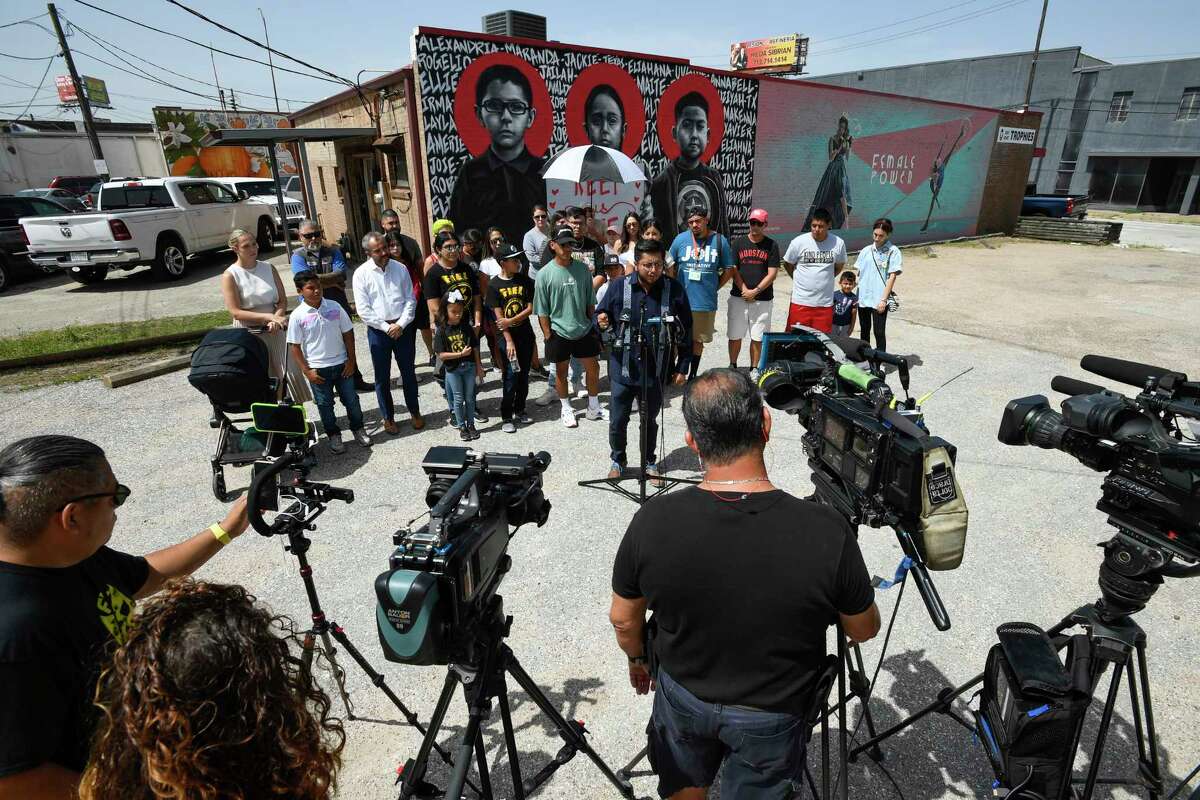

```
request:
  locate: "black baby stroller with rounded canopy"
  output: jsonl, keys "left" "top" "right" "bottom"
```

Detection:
{"left": 187, "top": 327, "right": 277, "bottom": 503}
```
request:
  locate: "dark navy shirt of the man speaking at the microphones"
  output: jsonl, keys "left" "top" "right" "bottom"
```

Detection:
{"left": 596, "top": 272, "right": 691, "bottom": 386}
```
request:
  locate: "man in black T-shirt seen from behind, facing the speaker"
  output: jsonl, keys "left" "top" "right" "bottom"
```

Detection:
{"left": 610, "top": 369, "right": 880, "bottom": 800}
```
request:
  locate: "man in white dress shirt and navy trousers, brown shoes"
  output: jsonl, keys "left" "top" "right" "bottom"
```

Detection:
{"left": 354, "top": 231, "right": 425, "bottom": 435}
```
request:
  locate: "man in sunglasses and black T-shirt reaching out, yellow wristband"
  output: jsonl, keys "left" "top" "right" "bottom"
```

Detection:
{"left": 0, "top": 435, "right": 247, "bottom": 800}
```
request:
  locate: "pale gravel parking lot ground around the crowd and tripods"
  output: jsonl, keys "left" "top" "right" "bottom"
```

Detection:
{"left": 0, "top": 240, "right": 1200, "bottom": 799}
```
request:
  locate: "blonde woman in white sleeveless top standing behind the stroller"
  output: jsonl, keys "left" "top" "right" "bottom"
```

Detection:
{"left": 221, "top": 229, "right": 312, "bottom": 403}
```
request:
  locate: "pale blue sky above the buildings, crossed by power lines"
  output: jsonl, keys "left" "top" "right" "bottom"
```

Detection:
{"left": 0, "top": 0, "right": 1200, "bottom": 121}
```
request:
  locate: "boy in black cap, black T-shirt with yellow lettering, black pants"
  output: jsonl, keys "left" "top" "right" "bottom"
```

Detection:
{"left": 487, "top": 242, "right": 535, "bottom": 433}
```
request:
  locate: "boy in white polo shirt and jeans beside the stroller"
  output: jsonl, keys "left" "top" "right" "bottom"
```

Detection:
{"left": 288, "top": 270, "right": 371, "bottom": 453}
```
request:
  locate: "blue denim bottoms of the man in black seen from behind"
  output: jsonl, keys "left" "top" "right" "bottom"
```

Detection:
{"left": 647, "top": 668, "right": 805, "bottom": 800}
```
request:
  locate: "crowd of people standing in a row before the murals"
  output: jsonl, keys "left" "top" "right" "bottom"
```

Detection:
{"left": 222, "top": 204, "right": 902, "bottom": 479}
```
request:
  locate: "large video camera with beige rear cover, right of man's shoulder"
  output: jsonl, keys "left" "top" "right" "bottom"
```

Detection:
{"left": 758, "top": 325, "right": 967, "bottom": 631}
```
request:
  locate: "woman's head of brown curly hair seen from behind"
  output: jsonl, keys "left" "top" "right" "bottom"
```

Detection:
{"left": 79, "top": 581, "right": 346, "bottom": 800}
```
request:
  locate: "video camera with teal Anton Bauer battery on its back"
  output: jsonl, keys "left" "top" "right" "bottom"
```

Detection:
{"left": 376, "top": 447, "right": 550, "bottom": 664}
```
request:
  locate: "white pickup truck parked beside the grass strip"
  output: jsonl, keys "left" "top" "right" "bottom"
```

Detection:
{"left": 20, "top": 178, "right": 282, "bottom": 283}
